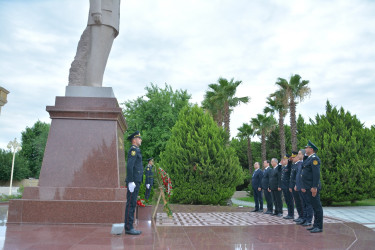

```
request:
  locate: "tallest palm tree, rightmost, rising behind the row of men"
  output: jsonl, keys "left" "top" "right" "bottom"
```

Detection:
{"left": 276, "top": 74, "right": 311, "bottom": 151}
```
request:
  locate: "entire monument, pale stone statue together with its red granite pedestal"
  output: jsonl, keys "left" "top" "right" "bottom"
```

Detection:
{"left": 7, "top": 0, "right": 127, "bottom": 224}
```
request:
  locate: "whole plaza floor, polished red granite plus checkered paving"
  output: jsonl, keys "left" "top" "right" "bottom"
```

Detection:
{"left": 0, "top": 204, "right": 375, "bottom": 250}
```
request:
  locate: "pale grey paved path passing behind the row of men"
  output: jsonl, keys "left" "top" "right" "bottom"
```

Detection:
{"left": 232, "top": 198, "right": 375, "bottom": 231}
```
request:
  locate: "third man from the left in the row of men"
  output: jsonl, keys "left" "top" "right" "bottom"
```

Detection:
{"left": 268, "top": 158, "right": 283, "bottom": 217}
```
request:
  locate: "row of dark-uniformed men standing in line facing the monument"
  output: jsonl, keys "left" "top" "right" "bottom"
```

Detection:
{"left": 252, "top": 141, "right": 323, "bottom": 233}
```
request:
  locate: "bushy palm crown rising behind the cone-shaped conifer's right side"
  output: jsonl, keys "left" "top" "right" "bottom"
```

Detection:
{"left": 203, "top": 77, "right": 250, "bottom": 136}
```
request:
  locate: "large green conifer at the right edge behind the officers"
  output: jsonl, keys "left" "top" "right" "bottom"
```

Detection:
{"left": 301, "top": 101, "right": 375, "bottom": 205}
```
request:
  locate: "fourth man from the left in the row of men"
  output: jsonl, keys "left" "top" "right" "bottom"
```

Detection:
{"left": 281, "top": 154, "right": 294, "bottom": 220}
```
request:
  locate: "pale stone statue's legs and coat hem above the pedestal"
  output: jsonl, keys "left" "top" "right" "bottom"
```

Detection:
{"left": 69, "top": 0, "right": 120, "bottom": 87}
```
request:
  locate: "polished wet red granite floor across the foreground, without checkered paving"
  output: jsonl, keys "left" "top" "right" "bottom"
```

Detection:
{"left": 4, "top": 221, "right": 375, "bottom": 250}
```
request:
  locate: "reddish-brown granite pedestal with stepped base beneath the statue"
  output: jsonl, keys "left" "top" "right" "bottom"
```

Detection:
{"left": 8, "top": 92, "right": 127, "bottom": 224}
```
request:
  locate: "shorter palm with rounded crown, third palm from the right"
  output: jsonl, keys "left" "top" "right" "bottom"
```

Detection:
{"left": 251, "top": 114, "right": 277, "bottom": 161}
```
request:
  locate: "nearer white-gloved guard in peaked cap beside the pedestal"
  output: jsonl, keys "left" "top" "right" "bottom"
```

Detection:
{"left": 125, "top": 131, "right": 143, "bottom": 235}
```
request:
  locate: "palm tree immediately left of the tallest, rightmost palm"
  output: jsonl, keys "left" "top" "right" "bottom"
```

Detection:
{"left": 263, "top": 89, "right": 288, "bottom": 157}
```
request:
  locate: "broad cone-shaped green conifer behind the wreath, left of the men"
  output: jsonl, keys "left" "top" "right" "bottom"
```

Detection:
{"left": 159, "top": 105, "right": 243, "bottom": 204}
